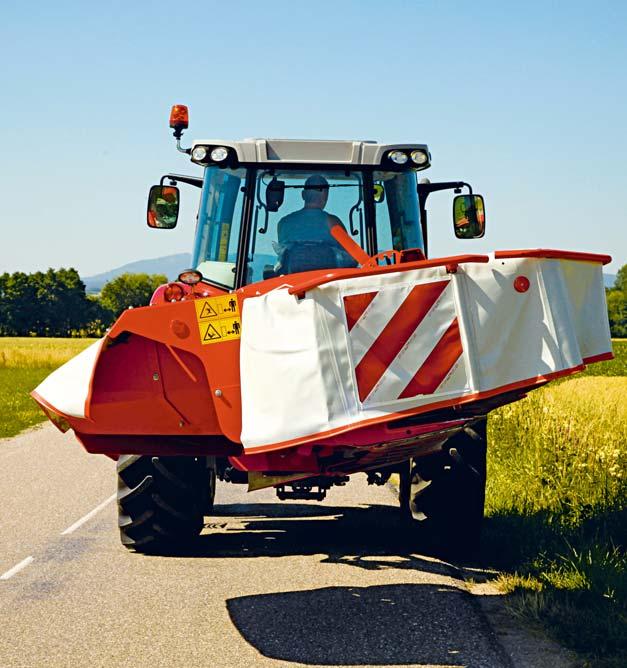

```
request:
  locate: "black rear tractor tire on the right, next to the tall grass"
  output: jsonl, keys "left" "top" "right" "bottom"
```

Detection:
{"left": 399, "top": 419, "right": 487, "bottom": 558}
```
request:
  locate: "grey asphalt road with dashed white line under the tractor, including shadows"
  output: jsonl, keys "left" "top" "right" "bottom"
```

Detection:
{"left": 0, "top": 425, "right": 568, "bottom": 668}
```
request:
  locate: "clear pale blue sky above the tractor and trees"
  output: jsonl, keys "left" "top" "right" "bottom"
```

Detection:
{"left": 0, "top": 0, "right": 627, "bottom": 276}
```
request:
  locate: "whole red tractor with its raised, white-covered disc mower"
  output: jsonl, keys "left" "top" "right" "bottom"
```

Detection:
{"left": 32, "top": 105, "right": 612, "bottom": 552}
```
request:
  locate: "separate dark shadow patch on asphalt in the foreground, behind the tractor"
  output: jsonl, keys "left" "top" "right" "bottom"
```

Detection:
{"left": 227, "top": 584, "right": 509, "bottom": 666}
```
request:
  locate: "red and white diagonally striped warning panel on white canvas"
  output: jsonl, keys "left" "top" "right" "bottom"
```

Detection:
{"left": 343, "top": 279, "right": 463, "bottom": 405}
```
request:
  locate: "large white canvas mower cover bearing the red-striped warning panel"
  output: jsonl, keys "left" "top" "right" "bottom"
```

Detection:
{"left": 241, "top": 251, "right": 611, "bottom": 449}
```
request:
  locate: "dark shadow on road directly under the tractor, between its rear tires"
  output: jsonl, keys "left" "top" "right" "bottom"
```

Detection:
{"left": 150, "top": 502, "right": 476, "bottom": 575}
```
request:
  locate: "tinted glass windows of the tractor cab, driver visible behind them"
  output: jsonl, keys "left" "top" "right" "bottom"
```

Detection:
{"left": 194, "top": 167, "right": 424, "bottom": 288}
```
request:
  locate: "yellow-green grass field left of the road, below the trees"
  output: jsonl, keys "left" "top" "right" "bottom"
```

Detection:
{"left": 0, "top": 337, "right": 93, "bottom": 438}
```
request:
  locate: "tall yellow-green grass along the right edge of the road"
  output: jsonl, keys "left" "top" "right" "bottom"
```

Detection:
{"left": 483, "top": 341, "right": 627, "bottom": 668}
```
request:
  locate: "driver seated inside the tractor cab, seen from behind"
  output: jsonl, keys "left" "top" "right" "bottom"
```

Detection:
{"left": 277, "top": 174, "right": 356, "bottom": 273}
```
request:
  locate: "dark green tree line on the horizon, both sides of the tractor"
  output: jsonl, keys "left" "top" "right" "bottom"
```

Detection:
{"left": 0, "top": 264, "right": 627, "bottom": 338}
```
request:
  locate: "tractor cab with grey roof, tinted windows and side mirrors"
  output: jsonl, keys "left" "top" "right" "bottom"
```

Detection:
{"left": 148, "top": 105, "right": 484, "bottom": 290}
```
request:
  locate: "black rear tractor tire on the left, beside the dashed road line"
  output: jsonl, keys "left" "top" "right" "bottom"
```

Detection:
{"left": 117, "top": 455, "right": 215, "bottom": 554}
